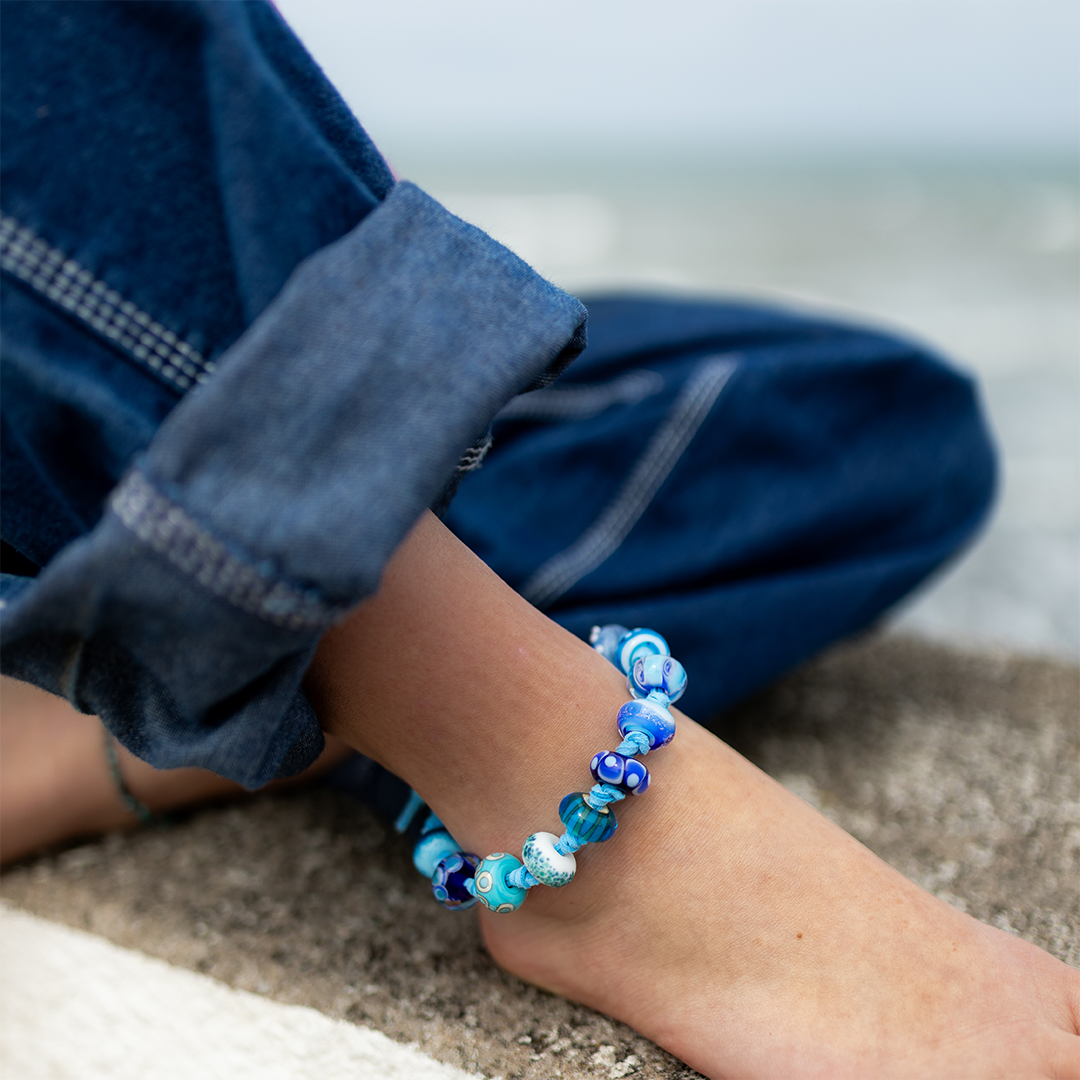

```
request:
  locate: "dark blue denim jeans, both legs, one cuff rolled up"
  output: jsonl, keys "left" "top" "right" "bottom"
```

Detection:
{"left": 0, "top": 0, "right": 994, "bottom": 786}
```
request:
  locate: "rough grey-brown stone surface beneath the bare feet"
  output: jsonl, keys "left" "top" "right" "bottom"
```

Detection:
{"left": 0, "top": 637, "right": 1080, "bottom": 1080}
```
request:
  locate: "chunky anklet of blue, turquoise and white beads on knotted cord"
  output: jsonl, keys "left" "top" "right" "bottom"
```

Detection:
{"left": 406, "top": 624, "right": 686, "bottom": 913}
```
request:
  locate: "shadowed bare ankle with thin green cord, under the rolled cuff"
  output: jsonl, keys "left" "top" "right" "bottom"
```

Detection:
{"left": 0, "top": 676, "right": 349, "bottom": 865}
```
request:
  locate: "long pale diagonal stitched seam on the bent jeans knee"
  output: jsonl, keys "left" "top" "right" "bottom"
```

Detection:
{"left": 521, "top": 356, "right": 735, "bottom": 609}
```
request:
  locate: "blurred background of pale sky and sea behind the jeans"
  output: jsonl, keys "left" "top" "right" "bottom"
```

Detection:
{"left": 276, "top": 0, "right": 1080, "bottom": 660}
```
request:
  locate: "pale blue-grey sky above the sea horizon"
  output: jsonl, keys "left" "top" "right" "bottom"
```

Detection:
{"left": 278, "top": 0, "right": 1080, "bottom": 154}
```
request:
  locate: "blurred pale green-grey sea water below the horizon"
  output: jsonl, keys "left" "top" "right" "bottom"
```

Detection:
{"left": 394, "top": 149, "right": 1080, "bottom": 659}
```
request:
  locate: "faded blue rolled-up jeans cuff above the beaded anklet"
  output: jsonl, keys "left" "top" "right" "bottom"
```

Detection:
{"left": 0, "top": 184, "right": 585, "bottom": 787}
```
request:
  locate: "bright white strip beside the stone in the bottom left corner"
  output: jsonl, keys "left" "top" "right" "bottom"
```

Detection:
{"left": 0, "top": 904, "right": 469, "bottom": 1080}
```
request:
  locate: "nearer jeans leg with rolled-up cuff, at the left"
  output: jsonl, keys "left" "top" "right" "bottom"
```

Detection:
{"left": 0, "top": 0, "right": 585, "bottom": 786}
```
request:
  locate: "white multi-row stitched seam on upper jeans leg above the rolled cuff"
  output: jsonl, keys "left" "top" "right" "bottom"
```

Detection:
{"left": 0, "top": 211, "right": 214, "bottom": 390}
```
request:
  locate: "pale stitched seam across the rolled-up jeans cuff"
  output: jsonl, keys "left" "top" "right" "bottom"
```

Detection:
{"left": 110, "top": 472, "right": 347, "bottom": 630}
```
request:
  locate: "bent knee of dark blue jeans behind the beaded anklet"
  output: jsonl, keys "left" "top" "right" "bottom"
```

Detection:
{"left": 447, "top": 297, "right": 995, "bottom": 719}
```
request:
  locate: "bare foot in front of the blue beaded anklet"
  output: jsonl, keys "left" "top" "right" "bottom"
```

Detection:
{"left": 482, "top": 720, "right": 1080, "bottom": 1080}
